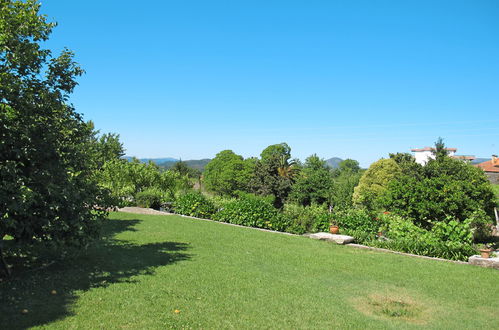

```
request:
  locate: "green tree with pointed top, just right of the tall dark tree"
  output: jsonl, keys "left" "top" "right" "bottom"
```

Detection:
{"left": 289, "top": 155, "right": 333, "bottom": 206}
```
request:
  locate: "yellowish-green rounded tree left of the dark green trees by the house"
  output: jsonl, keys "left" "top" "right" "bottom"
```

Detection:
{"left": 353, "top": 159, "right": 401, "bottom": 210}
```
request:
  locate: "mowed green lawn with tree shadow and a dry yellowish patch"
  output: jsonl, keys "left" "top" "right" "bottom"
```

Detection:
{"left": 0, "top": 213, "right": 499, "bottom": 329}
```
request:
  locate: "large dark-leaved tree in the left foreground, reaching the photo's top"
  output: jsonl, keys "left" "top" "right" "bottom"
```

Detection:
{"left": 0, "top": 0, "right": 114, "bottom": 271}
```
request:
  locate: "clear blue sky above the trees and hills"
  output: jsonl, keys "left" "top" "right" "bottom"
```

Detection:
{"left": 42, "top": 0, "right": 499, "bottom": 166}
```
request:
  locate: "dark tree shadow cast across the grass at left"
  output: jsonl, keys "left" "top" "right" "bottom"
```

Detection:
{"left": 0, "top": 220, "right": 190, "bottom": 329}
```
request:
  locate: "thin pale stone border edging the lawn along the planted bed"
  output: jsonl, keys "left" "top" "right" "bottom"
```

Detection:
{"left": 118, "top": 207, "right": 496, "bottom": 267}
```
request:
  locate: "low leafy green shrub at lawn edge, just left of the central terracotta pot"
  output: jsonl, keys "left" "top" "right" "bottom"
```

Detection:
{"left": 283, "top": 203, "right": 332, "bottom": 234}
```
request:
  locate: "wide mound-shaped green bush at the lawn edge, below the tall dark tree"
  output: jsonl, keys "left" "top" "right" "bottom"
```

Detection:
{"left": 213, "top": 194, "right": 289, "bottom": 231}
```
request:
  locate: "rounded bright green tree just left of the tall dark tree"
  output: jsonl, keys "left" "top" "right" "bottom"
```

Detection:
{"left": 203, "top": 150, "right": 255, "bottom": 196}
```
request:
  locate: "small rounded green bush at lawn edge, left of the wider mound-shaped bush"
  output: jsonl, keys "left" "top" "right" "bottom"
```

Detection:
{"left": 173, "top": 192, "right": 216, "bottom": 219}
